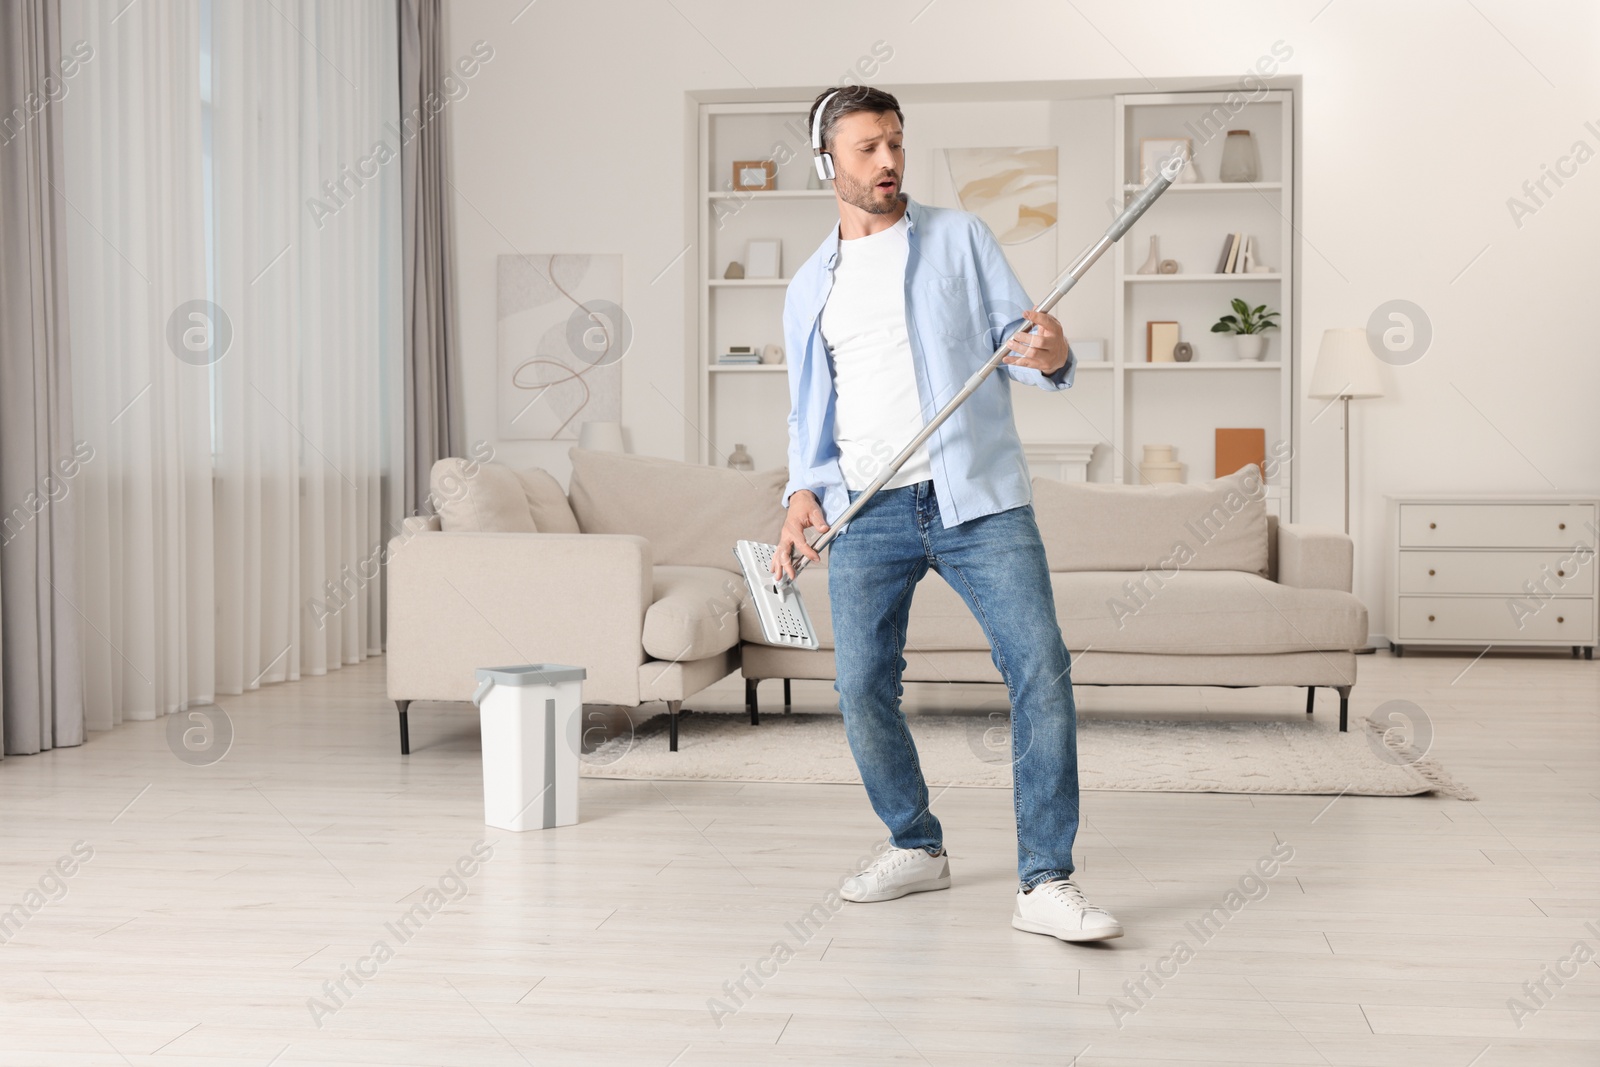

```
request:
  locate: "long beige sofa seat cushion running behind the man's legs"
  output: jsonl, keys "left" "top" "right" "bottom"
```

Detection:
{"left": 739, "top": 568, "right": 1366, "bottom": 657}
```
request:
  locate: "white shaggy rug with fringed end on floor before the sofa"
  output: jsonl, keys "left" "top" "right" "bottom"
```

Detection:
{"left": 582, "top": 712, "right": 1477, "bottom": 800}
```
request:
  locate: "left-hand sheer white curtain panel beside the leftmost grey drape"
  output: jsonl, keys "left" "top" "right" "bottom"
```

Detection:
{"left": 61, "top": 0, "right": 214, "bottom": 729}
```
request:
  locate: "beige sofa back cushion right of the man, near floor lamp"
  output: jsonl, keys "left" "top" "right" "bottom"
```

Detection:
{"left": 1034, "top": 466, "right": 1269, "bottom": 577}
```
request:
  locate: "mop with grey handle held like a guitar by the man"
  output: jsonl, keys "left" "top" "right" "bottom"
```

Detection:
{"left": 733, "top": 155, "right": 1184, "bottom": 651}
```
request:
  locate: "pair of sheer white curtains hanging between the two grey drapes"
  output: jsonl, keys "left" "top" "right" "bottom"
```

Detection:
{"left": 62, "top": 0, "right": 400, "bottom": 729}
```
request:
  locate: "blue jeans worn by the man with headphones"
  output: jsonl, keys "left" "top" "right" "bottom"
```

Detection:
{"left": 827, "top": 482, "right": 1078, "bottom": 889}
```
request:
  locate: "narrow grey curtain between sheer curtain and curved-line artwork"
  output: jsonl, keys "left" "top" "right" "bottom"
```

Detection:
{"left": 397, "top": 0, "right": 466, "bottom": 515}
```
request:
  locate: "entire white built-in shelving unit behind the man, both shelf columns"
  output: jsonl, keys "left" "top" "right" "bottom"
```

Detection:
{"left": 686, "top": 82, "right": 1299, "bottom": 520}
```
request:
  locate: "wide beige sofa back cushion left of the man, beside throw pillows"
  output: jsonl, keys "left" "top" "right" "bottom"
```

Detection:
{"left": 568, "top": 448, "right": 789, "bottom": 573}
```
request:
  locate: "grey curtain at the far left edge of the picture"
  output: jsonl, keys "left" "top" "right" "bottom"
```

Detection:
{"left": 0, "top": 0, "right": 83, "bottom": 755}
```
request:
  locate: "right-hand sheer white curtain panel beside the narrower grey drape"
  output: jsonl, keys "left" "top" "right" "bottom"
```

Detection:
{"left": 211, "top": 0, "right": 400, "bottom": 693}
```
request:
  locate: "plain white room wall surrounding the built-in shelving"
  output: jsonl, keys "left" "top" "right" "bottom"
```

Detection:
{"left": 450, "top": 0, "right": 1600, "bottom": 633}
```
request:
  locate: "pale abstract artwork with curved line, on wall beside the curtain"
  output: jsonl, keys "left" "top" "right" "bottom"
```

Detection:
{"left": 494, "top": 253, "right": 632, "bottom": 442}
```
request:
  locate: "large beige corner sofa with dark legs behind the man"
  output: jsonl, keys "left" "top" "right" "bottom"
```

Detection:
{"left": 386, "top": 448, "right": 1366, "bottom": 752}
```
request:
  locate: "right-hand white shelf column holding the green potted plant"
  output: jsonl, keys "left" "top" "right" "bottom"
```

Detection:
{"left": 1110, "top": 90, "right": 1299, "bottom": 520}
